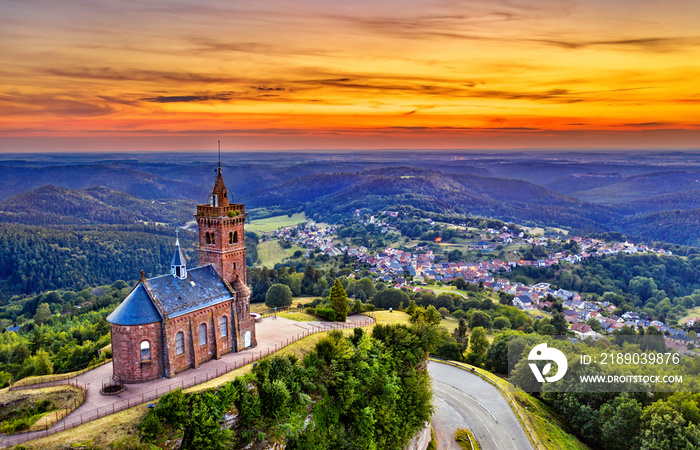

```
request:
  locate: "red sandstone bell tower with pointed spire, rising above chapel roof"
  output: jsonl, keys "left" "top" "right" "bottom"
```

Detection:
{"left": 195, "top": 153, "right": 246, "bottom": 285}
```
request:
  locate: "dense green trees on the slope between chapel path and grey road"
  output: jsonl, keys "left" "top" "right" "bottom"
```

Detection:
{"left": 140, "top": 324, "right": 436, "bottom": 450}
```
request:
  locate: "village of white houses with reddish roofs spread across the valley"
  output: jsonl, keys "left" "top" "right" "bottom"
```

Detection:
{"left": 272, "top": 211, "right": 694, "bottom": 353}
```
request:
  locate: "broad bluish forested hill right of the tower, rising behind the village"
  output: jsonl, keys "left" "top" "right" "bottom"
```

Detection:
{"left": 243, "top": 167, "right": 619, "bottom": 230}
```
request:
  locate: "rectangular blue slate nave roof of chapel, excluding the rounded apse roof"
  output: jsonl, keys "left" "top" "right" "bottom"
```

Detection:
{"left": 148, "top": 264, "right": 233, "bottom": 318}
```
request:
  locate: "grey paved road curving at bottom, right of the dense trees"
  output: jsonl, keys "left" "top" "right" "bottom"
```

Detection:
{"left": 428, "top": 361, "right": 532, "bottom": 450}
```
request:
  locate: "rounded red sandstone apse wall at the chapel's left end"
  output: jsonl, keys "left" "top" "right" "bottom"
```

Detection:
{"left": 110, "top": 322, "right": 163, "bottom": 383}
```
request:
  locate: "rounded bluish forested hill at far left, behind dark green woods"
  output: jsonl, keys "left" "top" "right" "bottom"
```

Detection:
{"left": 0, "top": 185, "right": 196, "bottom": 227}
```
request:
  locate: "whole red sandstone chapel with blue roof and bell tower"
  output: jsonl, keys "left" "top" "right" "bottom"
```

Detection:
{"left": 107, "top": 165, "right": 256, "bottom": 383}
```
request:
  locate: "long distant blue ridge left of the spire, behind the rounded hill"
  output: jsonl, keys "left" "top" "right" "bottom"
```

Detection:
{"left": 0, "top": 164, "right": 205, "bottom": 201}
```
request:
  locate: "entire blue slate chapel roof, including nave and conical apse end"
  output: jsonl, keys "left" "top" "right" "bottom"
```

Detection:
{"left": 107, "top": 264, "right": 233, "bottom": 325}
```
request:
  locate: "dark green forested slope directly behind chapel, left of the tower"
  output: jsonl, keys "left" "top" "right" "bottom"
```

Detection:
{"left": 0, "top": 224, "right": 199, "bottom": 301}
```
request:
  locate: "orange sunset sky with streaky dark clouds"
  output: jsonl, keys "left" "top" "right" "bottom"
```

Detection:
{"left": 0, "top": 0, "right": 700, "bottom": 152}
